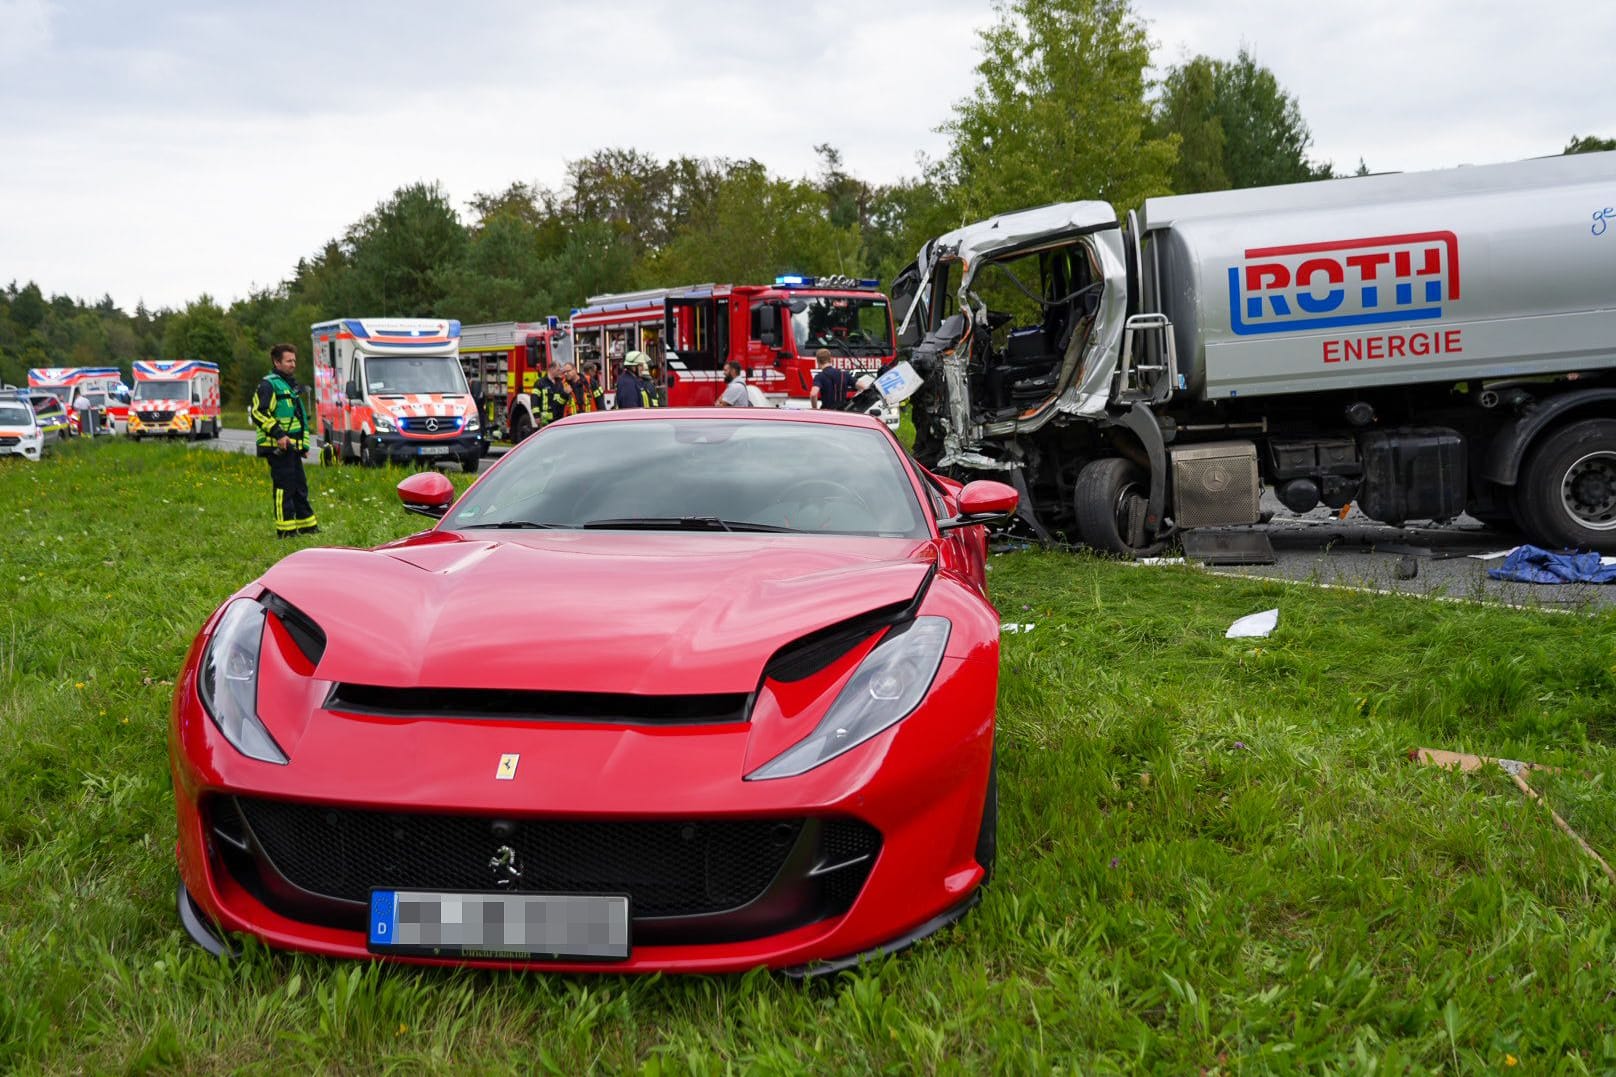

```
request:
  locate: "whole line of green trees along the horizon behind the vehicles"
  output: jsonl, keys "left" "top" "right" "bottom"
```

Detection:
{"left": 0, "top": 0, "right": 1616, "bottom": 401}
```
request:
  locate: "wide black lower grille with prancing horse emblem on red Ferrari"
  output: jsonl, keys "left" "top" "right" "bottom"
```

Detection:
{"left": 219, "top": 797, "right": 881, "bottom": 938}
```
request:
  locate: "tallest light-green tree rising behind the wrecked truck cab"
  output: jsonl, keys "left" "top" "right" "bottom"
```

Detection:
{"left": 942, "top": 0, "right": 1176, "bottom": 220}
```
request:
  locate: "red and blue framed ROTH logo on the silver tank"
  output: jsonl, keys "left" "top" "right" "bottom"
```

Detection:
{"left": 1228, "top": 231, "right": 1459, "bottom": 335}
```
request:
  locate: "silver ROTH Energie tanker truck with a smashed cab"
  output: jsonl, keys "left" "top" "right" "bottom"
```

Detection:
{"left": 882, "top": 152, "right": 1616, "bottom": 556}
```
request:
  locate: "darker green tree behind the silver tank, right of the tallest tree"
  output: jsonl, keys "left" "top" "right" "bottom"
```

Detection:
{"left": 1155, "top": 49, "right": 1333, "bottom": 194}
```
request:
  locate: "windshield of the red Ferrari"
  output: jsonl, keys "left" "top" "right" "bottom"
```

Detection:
{"left": 440, "top": 419, "right": 929, "bottom": 536}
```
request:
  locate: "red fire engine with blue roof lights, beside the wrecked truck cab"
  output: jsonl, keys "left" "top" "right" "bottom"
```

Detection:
{"left": 572, "top": 275, "right": 894, "bottom": 408}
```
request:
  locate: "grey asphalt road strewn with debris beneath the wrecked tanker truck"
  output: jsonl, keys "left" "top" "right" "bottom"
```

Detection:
{"left": 194, "top": 430, "right": 1616, "bottom": 610}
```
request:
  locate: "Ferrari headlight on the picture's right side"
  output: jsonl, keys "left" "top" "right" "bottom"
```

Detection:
{"left": 747, "top": 618, "right": 949, "bottom": 781}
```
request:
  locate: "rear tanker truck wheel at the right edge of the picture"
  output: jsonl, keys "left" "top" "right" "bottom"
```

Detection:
{"left": 1516, "top": 419, "right": 1616, "bottom": 553}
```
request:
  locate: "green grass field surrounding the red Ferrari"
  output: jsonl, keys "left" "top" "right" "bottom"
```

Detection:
{"left": 9, "top": 438, "right": 1616, "bottom": 1074}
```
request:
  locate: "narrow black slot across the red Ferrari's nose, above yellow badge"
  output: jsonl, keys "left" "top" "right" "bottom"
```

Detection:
{"left": 325, "top": 684, "right": 748, "bottom": 726}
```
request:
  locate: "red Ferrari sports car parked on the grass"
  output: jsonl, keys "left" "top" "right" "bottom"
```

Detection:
{"left": 170, "top": 409, "right": 1016, "bottom": 974}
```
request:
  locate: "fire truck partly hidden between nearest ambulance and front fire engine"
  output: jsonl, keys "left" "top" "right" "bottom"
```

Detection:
{"left": 461, "top": 317, "right": 572, "bottom": 441}
